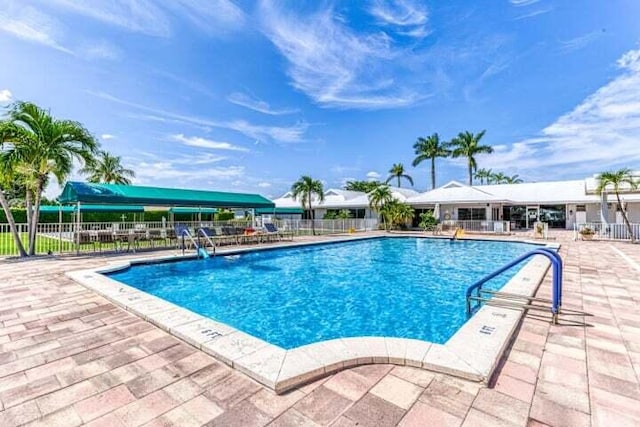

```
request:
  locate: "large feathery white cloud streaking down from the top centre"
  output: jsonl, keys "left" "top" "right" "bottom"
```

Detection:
{"left": 260, "top": 1, "right": 426, "bottom": 109}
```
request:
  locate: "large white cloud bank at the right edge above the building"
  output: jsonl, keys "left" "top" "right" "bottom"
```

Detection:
{"left": 481, "top": 49, "right": 640, "bottom": 175}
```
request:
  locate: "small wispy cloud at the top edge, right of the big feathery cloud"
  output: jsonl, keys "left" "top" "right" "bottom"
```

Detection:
{"left": 369, "top": 0, "right": 429, "bottom": 38}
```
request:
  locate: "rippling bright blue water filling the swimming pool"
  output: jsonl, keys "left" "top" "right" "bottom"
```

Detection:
{"left": 109, "top": 238, "right": 533, "bottom": 349}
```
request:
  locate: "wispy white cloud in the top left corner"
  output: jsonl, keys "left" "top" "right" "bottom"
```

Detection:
{"left": 0, "top": 0, "right": 73, "bottom": 55}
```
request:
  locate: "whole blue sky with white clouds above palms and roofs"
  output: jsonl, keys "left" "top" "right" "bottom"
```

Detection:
{"left": 0, "top": 0, "right": 640, "bottom": 197}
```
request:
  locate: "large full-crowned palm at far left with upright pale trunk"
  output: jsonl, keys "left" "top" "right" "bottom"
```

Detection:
{"left": 1, "top": 101, "right": 98, "bottom": 255}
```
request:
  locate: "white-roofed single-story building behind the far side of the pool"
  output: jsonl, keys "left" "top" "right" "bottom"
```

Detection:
{"left": 273, "top": 172, "right": 640, "bottom": 229}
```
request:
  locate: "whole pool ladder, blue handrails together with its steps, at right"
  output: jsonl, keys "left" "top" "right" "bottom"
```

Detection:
{"left": 466, "top": 248, "right": 589, "bottom": 324}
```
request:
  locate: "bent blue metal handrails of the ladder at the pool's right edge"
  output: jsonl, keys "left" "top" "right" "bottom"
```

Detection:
{"left": 466, "top": 248, "right": 562, "bottom": 323}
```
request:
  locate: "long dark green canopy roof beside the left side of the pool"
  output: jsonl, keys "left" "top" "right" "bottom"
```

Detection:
{"left": 58, "top": 182, "right": 274, "bottom": 208}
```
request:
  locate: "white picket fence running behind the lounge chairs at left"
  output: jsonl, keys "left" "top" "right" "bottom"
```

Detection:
{"left": 0, "top": 219, "right": 377, "bottom": 257}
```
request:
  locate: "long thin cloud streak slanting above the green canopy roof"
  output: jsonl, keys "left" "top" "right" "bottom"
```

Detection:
{"left": 87, "top": 91, "right": 309, "bottom": 143}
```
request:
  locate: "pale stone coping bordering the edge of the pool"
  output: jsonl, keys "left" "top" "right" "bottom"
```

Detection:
{"left": 66, "top": 234, "right": 559, "bottom": 394}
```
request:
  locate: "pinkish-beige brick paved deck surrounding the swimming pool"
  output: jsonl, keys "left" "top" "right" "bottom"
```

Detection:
{"left": 0, "top": 231, "right": 640, "bottom": 426}
